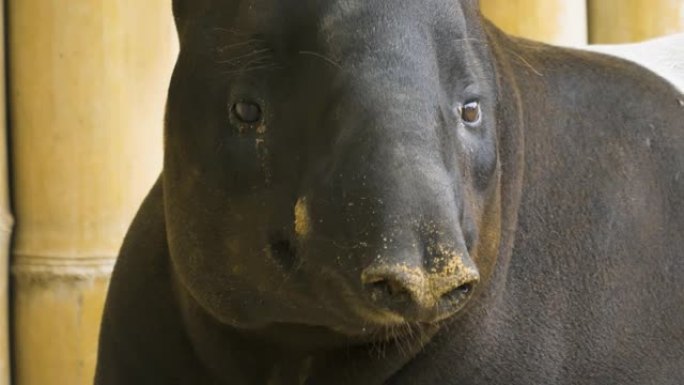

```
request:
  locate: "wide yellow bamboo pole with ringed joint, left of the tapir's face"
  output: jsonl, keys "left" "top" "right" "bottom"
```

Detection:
{"left": 8, "top": 0, "right": 176, "bottom": 385}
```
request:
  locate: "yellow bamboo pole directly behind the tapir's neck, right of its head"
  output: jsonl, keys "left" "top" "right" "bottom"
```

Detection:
{"left": 480, "top": 0, "right": 587, "bottom": 45}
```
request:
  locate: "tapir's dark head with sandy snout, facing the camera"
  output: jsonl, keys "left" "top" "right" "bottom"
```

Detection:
{"left": 163, "top": 0, "right": 500, "bottom": 335}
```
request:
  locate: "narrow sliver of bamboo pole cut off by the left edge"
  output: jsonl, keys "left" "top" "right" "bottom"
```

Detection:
{"left": 0, "top": 0, "right": 13, "bottom": 385}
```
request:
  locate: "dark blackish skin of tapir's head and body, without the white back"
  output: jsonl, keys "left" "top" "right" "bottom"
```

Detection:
{"left": 95, "top": 0, "right": 684, "bottom": 385}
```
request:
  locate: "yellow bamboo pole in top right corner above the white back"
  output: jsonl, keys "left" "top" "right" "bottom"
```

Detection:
{"left": 588, "top": 0, "right": 684, "bottom": 44}
